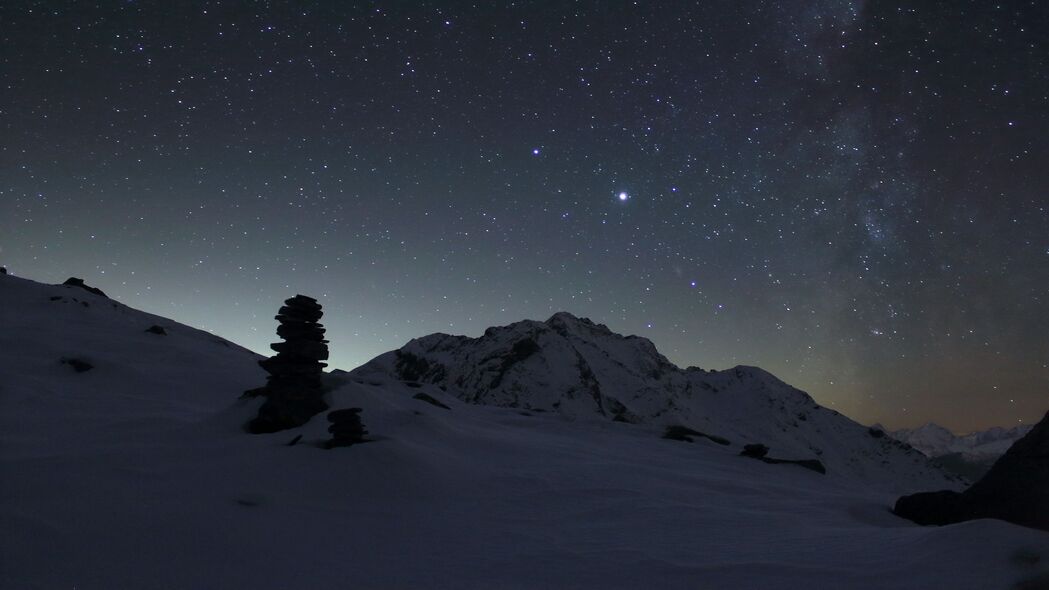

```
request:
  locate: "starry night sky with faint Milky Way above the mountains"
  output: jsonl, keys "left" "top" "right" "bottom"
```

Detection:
{"left": 0, "top": 0, "right": 1049, "bottom": 431}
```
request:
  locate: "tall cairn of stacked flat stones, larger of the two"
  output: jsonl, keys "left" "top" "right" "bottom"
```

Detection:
{"left": 244, "top": 295, "right": 328, "bottom": 434}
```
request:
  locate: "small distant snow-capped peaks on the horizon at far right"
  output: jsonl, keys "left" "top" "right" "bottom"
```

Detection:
{"left": 889, "top": 422, "right": 1033, "bottom": 462}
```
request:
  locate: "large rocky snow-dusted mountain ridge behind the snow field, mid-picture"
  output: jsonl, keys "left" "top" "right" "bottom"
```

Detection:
{"left": 352, "top": 313, "right": 959, "bottom": 492}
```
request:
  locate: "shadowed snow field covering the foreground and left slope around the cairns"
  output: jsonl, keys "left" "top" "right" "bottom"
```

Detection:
{"left": 0, "top": 276, "right": 1049, "bottom": 589}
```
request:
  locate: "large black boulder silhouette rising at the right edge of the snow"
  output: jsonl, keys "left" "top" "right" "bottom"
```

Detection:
{"left": 893, "top": 413, "right": 1049, "bottom": 530}
